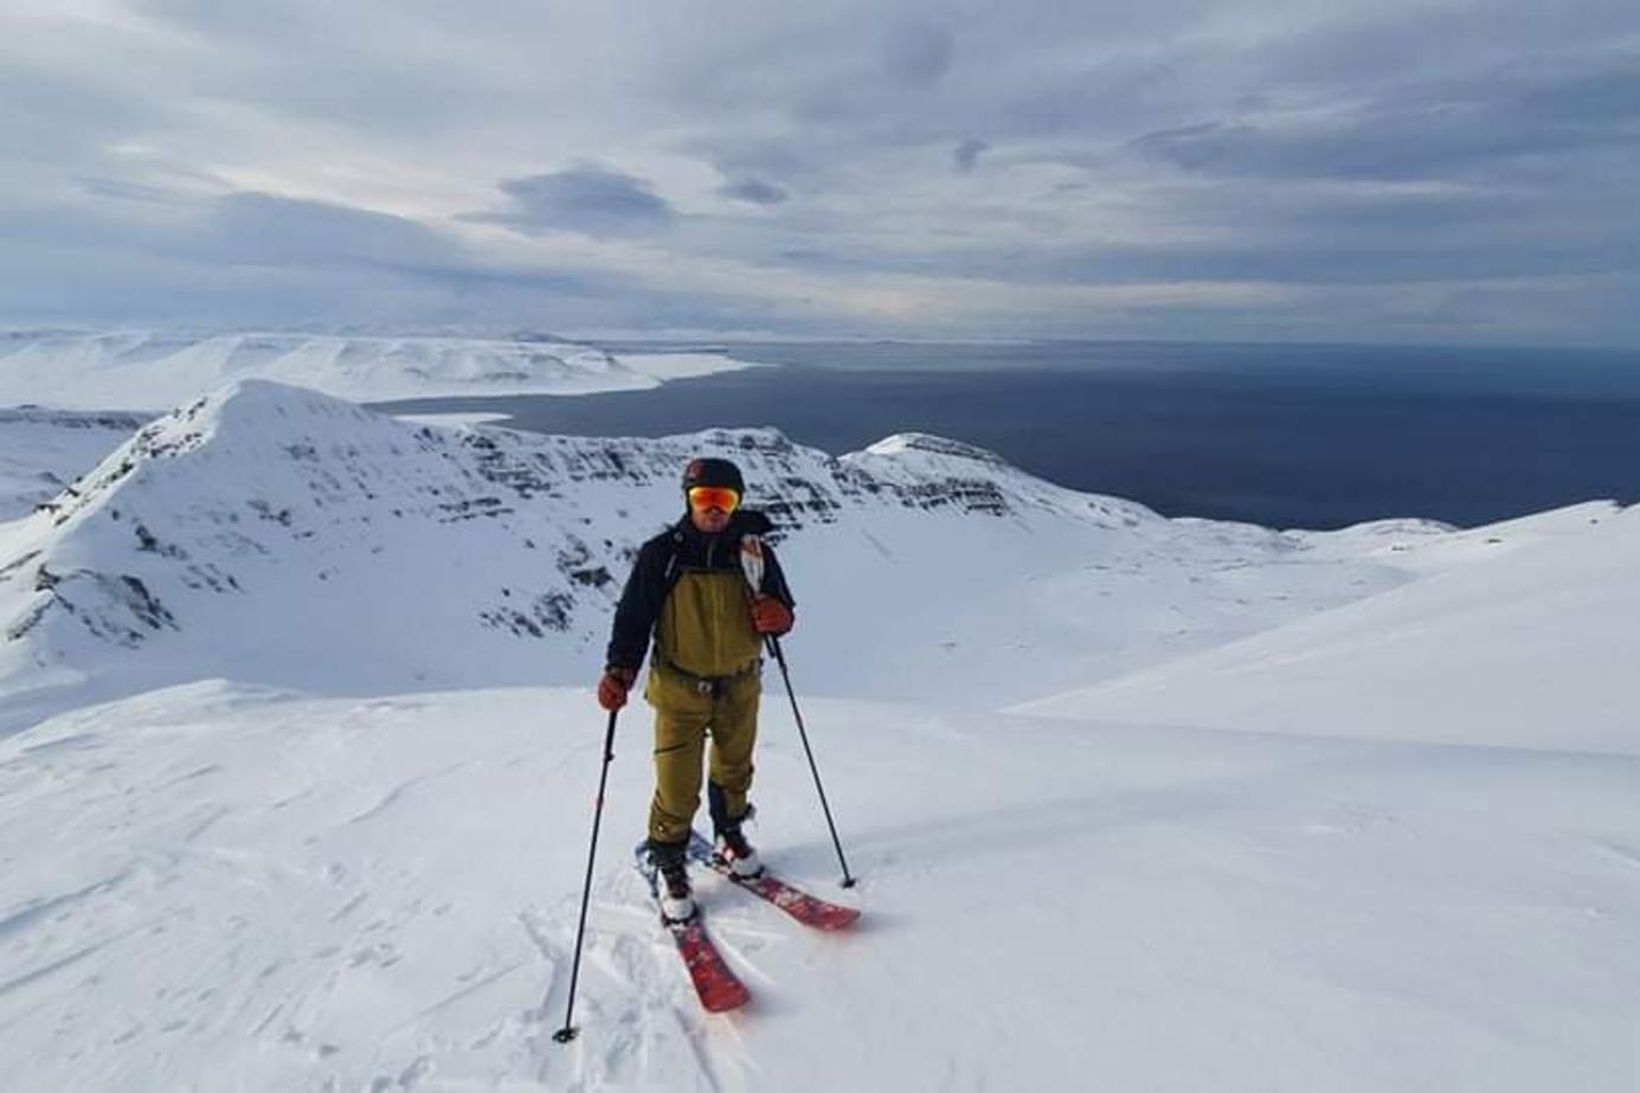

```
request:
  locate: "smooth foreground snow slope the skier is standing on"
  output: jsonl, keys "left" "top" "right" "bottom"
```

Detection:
{"left": 0, "top": 683, "right": 1640, "bottom": 1093}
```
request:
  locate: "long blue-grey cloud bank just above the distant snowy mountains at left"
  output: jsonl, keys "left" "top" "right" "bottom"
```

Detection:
{"left": 0, "top": 194, "right": 686, "bottom": 330}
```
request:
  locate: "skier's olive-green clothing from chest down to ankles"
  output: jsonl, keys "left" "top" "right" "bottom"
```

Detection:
{"left": 643, "top": 569, "right": 763, "bottom": 844}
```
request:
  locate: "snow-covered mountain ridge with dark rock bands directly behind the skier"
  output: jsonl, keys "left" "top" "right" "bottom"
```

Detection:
{"left": 0, "top": 381, "right": 1440, "bottom": 728}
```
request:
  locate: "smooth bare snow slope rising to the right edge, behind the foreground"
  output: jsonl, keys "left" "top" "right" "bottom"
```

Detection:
{"left": 1018, "top": 504, "right": 1640, "bottom": 755}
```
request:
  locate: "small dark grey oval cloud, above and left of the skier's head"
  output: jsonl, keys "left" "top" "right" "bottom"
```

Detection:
{"left": 462, "top": 166, "right": 676, "bottom": 236}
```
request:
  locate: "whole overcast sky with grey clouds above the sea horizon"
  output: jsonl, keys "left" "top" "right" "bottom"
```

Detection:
{"left": 0, "top": 0, "right": 1640, "bottom": 346}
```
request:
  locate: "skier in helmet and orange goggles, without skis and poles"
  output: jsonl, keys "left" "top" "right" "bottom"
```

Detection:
{"left": 599, "top": 458, "right": 794, "bottom": 922}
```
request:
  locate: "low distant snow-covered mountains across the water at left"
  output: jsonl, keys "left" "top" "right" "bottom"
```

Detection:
{"left": 0, "top": 330, "right": 749, "bottom": 412}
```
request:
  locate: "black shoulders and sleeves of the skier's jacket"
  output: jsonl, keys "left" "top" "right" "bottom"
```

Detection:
{"left": 604, "top": 509, "right": 797, "bottom": 673}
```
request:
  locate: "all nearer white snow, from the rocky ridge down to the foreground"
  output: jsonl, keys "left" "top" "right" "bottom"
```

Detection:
{"left": 0, "top": 382, "right": 1640, "bottom": 1093}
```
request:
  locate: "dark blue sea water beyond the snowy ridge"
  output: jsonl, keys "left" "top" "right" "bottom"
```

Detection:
{"left": 375, "top": 341, "right": 1640, "bottom": 528}
